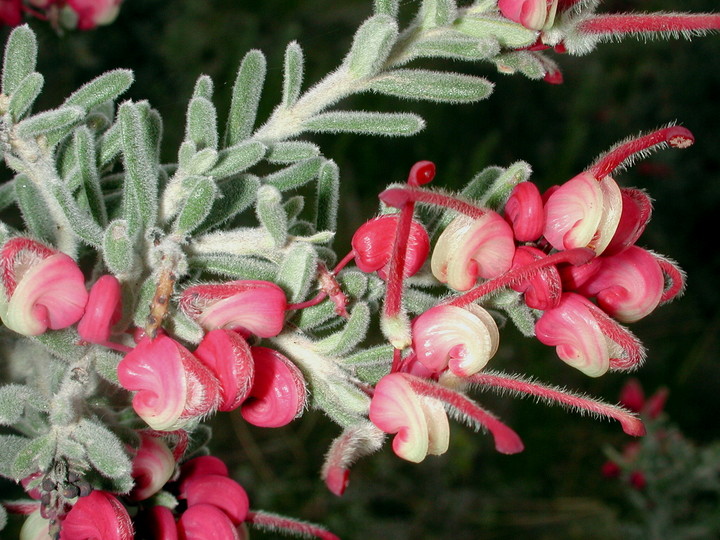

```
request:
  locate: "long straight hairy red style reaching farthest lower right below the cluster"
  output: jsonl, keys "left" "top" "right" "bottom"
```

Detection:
{"left": 469, "top": 371, "right": 645, "bottom": 437}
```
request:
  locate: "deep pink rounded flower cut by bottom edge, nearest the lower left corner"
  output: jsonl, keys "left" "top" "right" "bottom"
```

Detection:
{"left": 60, "top": 490, "right": 134, "bottom": 540}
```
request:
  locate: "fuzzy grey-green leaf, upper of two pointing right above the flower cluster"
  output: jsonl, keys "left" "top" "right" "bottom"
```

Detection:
{"left": 368, "top": 69, "right": 493, "bottom": 103}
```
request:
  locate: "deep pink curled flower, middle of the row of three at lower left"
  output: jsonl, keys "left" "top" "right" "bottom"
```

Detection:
{"left": 194, "top": 329, "right": 255, "bottom": 411}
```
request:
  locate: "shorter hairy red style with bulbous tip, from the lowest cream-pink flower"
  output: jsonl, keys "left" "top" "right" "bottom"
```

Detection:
{"left": 403, "top": 373, "right": 524, "bottom": 454}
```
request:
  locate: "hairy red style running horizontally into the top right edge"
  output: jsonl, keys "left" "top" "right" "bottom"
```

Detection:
{"left": 578, "top": 13, "right": 720, "bottom": 35}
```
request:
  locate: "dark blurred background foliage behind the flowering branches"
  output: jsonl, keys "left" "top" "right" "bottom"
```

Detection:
{"left": 2, "top": 0, "right": 720, "bottom": 540}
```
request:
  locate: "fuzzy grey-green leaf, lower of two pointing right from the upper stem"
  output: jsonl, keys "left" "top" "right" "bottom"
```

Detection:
{"left": 303, "top": 111, "right": 425, "bottom": 137}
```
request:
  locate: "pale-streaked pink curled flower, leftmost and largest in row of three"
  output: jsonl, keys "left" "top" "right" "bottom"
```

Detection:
{"left": 118, "top": 335, "right": 220, "bottom": 431}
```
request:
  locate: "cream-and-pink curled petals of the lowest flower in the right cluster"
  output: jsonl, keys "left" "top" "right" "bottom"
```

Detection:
{"left": 369, "top": 373, "right": 429, "bottom": 463}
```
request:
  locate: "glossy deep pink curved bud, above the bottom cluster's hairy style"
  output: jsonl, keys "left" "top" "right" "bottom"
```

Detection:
{"left": 178, "top": 474, "right": 250, "bottom": 525}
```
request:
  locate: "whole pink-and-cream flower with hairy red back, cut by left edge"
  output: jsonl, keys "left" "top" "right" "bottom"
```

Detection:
{"left": 0, "top": 238, "right": 88, "bottom": 336}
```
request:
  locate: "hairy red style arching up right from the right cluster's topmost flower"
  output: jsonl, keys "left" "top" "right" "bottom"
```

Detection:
{"left": 587, "top": 126, "right": 695, "bottom": 180}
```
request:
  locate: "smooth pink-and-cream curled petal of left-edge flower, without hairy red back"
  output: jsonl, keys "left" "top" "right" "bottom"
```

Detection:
{"left": 2, "top": 253, "right": 88, "bottom": 336}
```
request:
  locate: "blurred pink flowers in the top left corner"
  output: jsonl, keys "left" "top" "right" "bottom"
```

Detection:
{"left": 0, "top": 0, "right": 122, "bottom": 30}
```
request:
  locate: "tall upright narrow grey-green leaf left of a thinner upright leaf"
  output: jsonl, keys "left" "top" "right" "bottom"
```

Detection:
{"left": 225, "top": 50, "right": 267, "bottom": 146}
